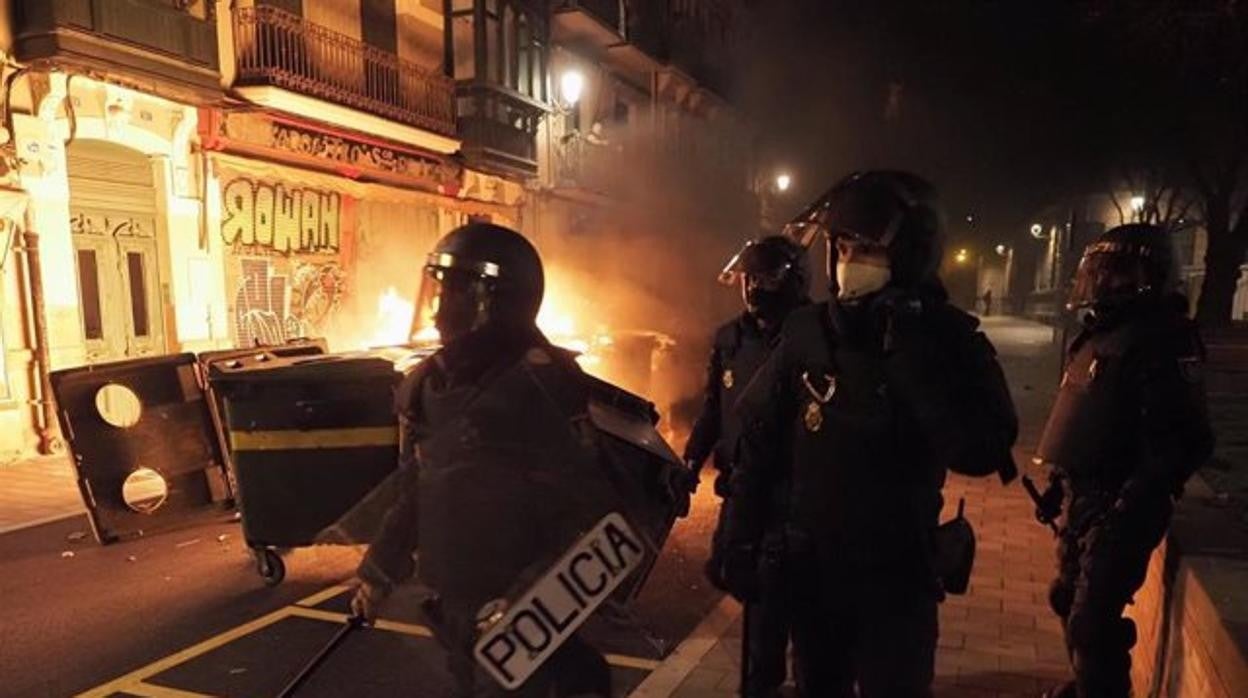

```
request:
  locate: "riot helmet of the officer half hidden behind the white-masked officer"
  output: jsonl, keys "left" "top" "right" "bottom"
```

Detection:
{"left": 738, "top": 235, "right": 810, "bottom": 322}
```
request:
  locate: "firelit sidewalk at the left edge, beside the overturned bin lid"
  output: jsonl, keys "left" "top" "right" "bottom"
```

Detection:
{"left": 0, "top": 456, "right": 86, "bottom": 533}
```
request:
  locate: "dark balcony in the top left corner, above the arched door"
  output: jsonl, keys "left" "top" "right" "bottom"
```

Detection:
{"left": 10, "top": 0, "right": 221, "bottom": 95}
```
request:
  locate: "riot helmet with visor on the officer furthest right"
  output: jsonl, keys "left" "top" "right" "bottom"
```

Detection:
{"left": 1066, "top": 224, "right": 1176, "bottom": 311}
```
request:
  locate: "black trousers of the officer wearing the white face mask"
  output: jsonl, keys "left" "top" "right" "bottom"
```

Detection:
{"left": 785, "top": 552, "right": 938, "bottom": 698}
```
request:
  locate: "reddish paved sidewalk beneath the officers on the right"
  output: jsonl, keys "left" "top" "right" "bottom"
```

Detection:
{"left": 633, "top": 466, "right": 1068, "bottom": 698}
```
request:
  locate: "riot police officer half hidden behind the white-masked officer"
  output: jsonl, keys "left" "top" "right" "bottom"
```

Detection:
{"left": 684, "top": 235, "right": 810, "bottom": 697}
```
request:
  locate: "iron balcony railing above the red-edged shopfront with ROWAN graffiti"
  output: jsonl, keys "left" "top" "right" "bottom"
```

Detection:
{"left": 233, "top": 5, "right": 456, "bottom": 136}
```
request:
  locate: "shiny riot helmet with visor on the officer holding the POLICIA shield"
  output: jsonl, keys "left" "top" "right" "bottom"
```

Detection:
{"left": 412, "top": 224, "right": 545, "bottom": 343}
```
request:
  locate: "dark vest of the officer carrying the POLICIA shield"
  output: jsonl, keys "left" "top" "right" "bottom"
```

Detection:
{"left": 404, "top": 348, "right": 620, "bottom": 608}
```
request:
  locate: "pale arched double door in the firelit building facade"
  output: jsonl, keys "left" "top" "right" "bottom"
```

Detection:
{"left": 67, "top": 141, "right": 165, "bottom": 363}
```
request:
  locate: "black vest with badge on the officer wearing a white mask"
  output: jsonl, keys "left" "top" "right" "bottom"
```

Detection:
{"left": 748, "top": 303, "right": 945, "bottom": 583}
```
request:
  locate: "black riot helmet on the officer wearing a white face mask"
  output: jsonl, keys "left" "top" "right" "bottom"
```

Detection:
{"left": 819, "top": 170, "right": 943, "bottom": 292}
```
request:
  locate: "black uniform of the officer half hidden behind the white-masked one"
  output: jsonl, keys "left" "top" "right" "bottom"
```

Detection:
{"left": 685, "top": 312, "right": 789, "bottom": 696}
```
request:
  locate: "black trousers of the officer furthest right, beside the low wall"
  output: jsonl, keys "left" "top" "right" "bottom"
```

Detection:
{"left": 1050, "top": 492, "right": 1173, "bottom": 698}
